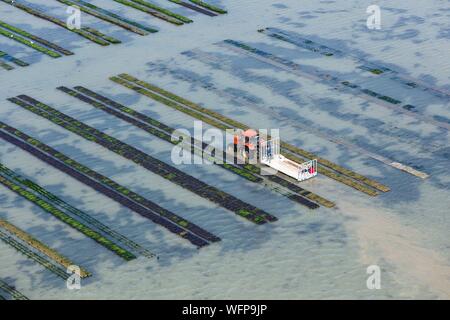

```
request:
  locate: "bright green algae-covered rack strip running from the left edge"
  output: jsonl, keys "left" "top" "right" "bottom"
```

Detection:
{"left": 0, "top": 172, "right": 136, "bottom": 261}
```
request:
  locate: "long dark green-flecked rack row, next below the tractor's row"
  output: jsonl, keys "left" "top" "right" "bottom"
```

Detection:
{"left": 9, "top": 95, "right": 278, "bottom": 224}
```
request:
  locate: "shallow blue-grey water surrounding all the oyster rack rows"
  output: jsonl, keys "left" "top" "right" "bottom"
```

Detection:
{"left": 0, "top": 0, "right": 450, "bottom": 299}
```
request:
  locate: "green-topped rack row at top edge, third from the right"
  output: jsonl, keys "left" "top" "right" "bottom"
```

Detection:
{"left": 57, "top": 0, "right": 158, "bottom": 36}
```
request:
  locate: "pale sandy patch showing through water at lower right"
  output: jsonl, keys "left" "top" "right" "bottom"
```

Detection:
{"left": 338, "top": 199, "right": 450, "bottom": 299}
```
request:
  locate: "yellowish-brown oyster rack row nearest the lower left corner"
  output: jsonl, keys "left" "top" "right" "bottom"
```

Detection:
{"left": 0, "top": 219, "right": 91, "bottom": 278}
